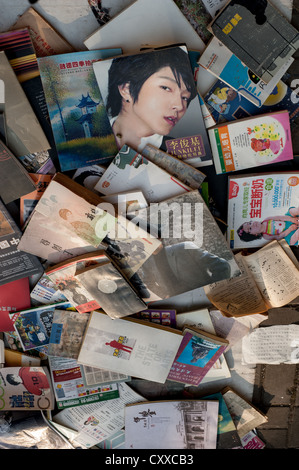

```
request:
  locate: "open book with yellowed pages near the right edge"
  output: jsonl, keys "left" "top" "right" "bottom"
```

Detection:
{"left": 204, "top": 240, "right": 299, "bottom": 316}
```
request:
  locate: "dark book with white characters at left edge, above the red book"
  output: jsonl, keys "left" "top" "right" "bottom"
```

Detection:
{"left": 0, "top": 200, "right": 44, "bottom": 286}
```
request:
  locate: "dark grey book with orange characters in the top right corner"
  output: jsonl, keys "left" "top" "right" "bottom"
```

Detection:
{"left": 208, "top": 0, "right": 299, "bottom": 83}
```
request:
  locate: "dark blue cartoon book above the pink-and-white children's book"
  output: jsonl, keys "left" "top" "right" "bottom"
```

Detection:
{"left": 204, "top": 80, "right": 299, "bottom": 125}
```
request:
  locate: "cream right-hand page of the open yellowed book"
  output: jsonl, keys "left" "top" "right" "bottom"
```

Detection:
{"left": 244, "top": 241, "right": 299, "bottom": 308}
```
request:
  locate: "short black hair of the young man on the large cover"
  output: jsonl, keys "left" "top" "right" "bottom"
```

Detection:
{"left": 106, "top": 47, "right": 197, "bottom": 117}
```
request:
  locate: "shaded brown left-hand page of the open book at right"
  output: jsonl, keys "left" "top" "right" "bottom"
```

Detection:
{"left": 204, "top": 253, "right": 268, "bottom": 316}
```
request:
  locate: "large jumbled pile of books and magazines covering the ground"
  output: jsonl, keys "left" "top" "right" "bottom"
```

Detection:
{"left": 0, "top": 0, "right": 299, "bottom": 449}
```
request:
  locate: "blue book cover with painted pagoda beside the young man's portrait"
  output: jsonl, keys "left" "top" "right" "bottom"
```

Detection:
{"left": 38, "top": 49, "right": 122, "bottom": 171}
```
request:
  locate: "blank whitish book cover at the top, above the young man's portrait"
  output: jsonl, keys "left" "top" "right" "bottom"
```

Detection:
{"left": 84, "top": 0, "right": 205, "bottom": 54}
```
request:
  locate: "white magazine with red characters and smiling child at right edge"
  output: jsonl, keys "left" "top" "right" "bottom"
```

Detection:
{"left": 227, "top": 172, "right": 299, "bottom": 249}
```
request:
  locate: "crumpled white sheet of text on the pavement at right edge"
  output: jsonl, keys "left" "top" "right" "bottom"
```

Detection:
{"left": 242, "top": 324, "right": 299, "bottom": 364}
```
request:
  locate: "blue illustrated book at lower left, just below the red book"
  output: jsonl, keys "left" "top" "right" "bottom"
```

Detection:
{"left": 10, "top": 302, "right": 72, "bottom": 351}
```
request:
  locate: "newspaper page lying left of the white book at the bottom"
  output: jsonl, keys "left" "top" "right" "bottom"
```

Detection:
{"left": 53, "top": 383, "right": 145, "bottom": 449}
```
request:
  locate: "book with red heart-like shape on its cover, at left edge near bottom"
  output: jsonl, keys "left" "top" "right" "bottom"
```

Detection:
{"left": 0, "top": 366, "right": 55, "bottom": 411}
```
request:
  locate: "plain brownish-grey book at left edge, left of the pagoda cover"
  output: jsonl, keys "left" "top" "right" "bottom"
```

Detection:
{"left": 0, "top": 51, "right": 50, "bottom": 157}
